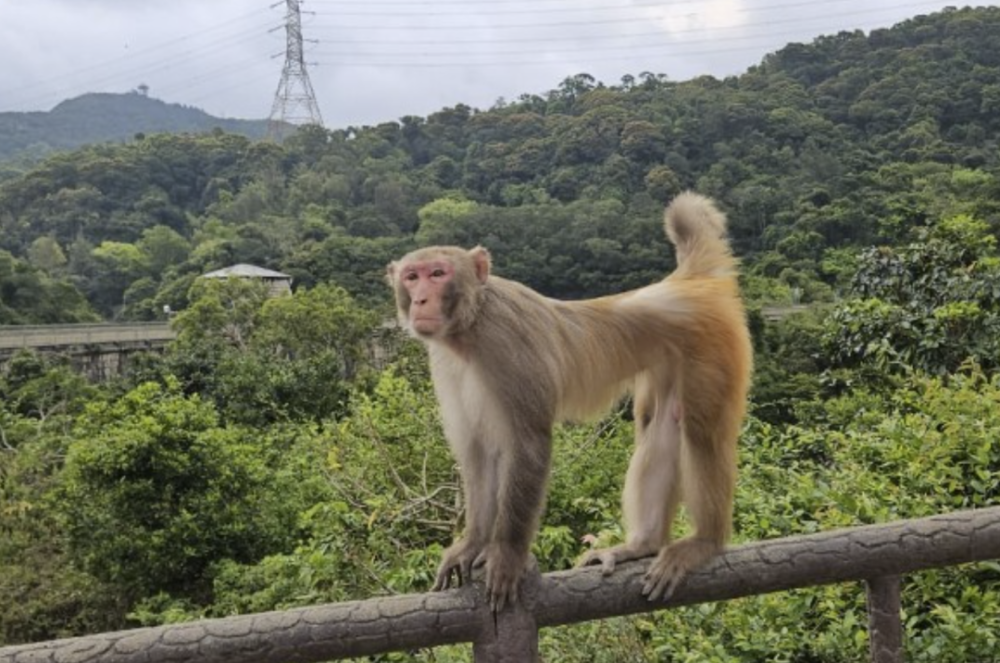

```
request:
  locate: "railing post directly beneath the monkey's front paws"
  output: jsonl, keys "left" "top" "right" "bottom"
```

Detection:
{"left": 472, "top": 557, "right": 542, "bottom": 663}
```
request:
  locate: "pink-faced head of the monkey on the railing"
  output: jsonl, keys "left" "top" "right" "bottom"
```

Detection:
{"left": 386, "top": 246, "right": 490, "bottom": 340}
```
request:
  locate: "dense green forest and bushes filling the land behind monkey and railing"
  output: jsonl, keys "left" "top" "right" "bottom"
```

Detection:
{"left": 0, "top": 7, "right": 1000, "bottom": 663}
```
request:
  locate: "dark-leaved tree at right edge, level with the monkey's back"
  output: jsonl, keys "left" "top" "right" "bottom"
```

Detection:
{"left": 825, "top": 216, "right": 1000, "bottom": 373}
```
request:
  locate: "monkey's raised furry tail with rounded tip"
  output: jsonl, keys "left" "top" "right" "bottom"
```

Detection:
{"left": 663, "top": 191, "right": 736, "bottom": 278}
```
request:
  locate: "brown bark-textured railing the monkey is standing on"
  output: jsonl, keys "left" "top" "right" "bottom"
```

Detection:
{"left": 0, "top": 507, "right": 1000, "bottom": 663}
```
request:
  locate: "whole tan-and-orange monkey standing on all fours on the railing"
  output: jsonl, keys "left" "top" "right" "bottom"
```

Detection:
{"left": 388, "top": 193, "right": 752, "bottom": 610}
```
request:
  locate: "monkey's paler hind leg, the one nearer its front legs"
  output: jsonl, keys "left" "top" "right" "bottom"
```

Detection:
{"left": 579, "top": 389, "right": 681, "bottom": 575}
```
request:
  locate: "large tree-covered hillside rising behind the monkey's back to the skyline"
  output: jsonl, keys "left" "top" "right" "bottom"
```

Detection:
{"left": 0, "top": 7, "right": 1000, "bottom": 320}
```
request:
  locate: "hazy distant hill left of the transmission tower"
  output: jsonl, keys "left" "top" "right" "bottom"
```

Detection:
{"left": 0, "top": 93, "right": 267, "bottom": 163}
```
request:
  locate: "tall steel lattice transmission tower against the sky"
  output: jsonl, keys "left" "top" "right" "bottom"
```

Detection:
{"left": 267, "top": 0, "right": 323, "bottom": 140}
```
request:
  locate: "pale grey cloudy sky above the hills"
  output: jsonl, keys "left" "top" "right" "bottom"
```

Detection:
{"left": 0, "top": 0, "right": 1000, "bottom": 128}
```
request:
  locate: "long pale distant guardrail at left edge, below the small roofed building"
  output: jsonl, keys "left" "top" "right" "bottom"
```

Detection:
{"left": 0, "top": 322, "right": 177, "bottom": 353}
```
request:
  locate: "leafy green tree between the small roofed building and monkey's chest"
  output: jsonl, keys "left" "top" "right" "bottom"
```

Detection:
{"left": 167, "top": 279, "right": 378, "bottom": 426}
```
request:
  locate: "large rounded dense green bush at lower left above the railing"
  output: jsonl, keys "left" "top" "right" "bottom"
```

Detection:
{"left": 57, "top": 381, "right": 295, "bottom": 599}
